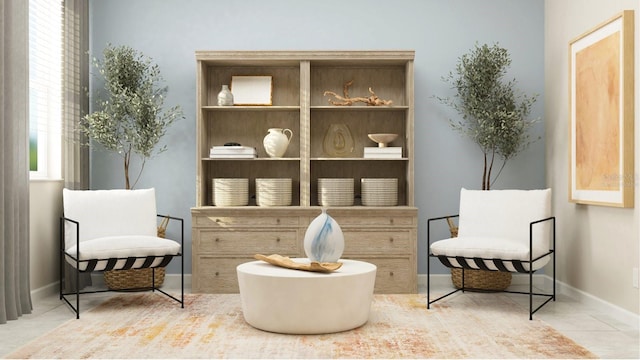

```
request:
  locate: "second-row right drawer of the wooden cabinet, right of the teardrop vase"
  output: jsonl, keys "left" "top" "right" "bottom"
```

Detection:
{"left": 343, "top": 229, "right": 413, "bottom": 255}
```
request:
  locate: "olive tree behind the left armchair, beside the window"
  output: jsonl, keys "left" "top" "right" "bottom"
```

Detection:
{"left": 80, "top": 44, "right": 183, "bottom": 189}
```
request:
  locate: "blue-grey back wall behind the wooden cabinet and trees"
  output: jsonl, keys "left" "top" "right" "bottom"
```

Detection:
{"left": 91, "top": 0, "right": 545, "bottom": 273}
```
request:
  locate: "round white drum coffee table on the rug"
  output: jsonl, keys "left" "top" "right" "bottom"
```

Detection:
{"left": 236, "top": 258, "right": 376, "bottom": 334}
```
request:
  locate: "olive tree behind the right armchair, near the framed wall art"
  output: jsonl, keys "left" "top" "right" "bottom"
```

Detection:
{"left": 436, "top": 44, "right": 537, "bottom": 190}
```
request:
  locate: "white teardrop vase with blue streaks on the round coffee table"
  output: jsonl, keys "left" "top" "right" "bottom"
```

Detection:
{"left": 304, "top": 208, "right": 344, "bottom": 262}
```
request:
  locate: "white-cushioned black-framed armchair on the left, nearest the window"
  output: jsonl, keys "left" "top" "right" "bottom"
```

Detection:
{"left": 60, "top": 189, "right": 184, "bottom": 318}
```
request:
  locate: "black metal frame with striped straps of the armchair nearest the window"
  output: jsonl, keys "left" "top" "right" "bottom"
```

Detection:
{"left": 60, "top": 214, "right": 184, "bottom": 319}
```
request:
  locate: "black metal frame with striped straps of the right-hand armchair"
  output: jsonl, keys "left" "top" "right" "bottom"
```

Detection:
{"left": 427, "top": 214, "right": 556, "bottom": 320}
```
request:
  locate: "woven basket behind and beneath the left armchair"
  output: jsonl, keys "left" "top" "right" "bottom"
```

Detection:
{"left": 104, "top": 217, "right": 169, "bottom": 290}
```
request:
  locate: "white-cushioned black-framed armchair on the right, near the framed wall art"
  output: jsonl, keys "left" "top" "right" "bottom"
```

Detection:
{"left": 427, "top": 189, "right": 556, "bottom": 319}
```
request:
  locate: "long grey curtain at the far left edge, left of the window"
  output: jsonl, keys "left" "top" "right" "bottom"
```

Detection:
{"left": 0, "top": 0, "right": 33, "bottom": 324}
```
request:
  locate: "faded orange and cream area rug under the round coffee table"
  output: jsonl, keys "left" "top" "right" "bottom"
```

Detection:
{"left": 8, "top": 293, "right": 595, "bottom": 359}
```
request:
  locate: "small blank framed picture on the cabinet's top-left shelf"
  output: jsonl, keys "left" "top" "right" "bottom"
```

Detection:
{"left": 231, "top": 76, "right": 273, "bottom": 105}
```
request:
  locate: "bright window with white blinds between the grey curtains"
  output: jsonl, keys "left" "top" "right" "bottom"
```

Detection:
{"left": 29, "top": 0, "right": 62, "bottom": 179}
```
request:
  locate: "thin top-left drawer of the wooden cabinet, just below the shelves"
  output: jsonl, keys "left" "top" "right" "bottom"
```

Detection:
{"left": 193, "top": 215, "right": 299, "bottom": 228}
